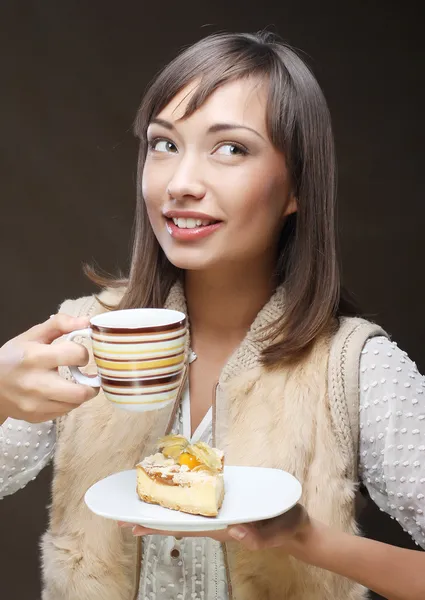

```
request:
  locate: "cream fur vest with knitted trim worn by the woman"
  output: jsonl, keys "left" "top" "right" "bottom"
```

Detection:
{"left": 42, "top": 284, "right": 383, "bottom": 600}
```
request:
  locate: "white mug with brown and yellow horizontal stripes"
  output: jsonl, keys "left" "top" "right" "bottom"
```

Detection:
{"left": 67, "top": 308, "right": 187, "bottom": 412}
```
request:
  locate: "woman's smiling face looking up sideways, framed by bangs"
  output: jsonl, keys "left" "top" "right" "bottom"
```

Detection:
{"left": 142, "top": 79, "right": 296, "bottom": 269}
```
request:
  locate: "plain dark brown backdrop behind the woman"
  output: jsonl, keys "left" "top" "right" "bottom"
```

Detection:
{"left": 0, "top": 0, "right": 425, "bottom": 600}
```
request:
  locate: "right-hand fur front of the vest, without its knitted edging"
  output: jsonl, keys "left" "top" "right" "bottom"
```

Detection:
{"left": 217, "top": 343, "right": 364, "bottom": 600}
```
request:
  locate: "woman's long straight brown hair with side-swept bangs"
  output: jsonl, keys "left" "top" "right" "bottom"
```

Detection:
{"left": 91, "top": 32, "right": 351, "bottom": 365}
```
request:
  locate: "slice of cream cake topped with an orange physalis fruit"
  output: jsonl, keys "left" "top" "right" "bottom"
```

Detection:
{"left": 137, "top": 435, "right": 224, "bottom": 517}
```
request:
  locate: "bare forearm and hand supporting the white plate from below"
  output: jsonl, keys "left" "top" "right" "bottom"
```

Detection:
{"left": 220, "top": 505, "right": 425, "bottom": 600}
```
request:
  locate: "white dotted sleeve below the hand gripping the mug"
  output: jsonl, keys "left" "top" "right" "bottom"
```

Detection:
{"left": 0, "top": 419, "right": 56, "bottom": 499}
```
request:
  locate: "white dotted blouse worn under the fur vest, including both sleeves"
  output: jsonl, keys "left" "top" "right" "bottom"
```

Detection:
{"left": 0, "top": 337, "right": 425, "bottom": 600}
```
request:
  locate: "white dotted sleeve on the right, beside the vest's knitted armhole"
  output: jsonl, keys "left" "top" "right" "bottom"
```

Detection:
{"left": 359, "top": 337, "right": 425, "bottom": 548}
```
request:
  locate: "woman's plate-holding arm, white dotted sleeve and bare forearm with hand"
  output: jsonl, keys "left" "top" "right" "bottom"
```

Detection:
{"left": 225, "top": 338, "right": 425, "bottom": 600}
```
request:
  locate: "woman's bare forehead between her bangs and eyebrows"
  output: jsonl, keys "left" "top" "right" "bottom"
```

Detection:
{"left": 157, "top": 77, "right": 268, "bottom": 132}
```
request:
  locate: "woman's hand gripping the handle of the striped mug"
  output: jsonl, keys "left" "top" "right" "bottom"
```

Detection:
{"left": 0, "top": 314, "right": 99, "bottom": 423}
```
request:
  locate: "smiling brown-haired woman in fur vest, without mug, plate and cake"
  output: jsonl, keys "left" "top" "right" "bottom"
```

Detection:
{"left": 0, "top": 34, "right": 425, "bottom": 600}
